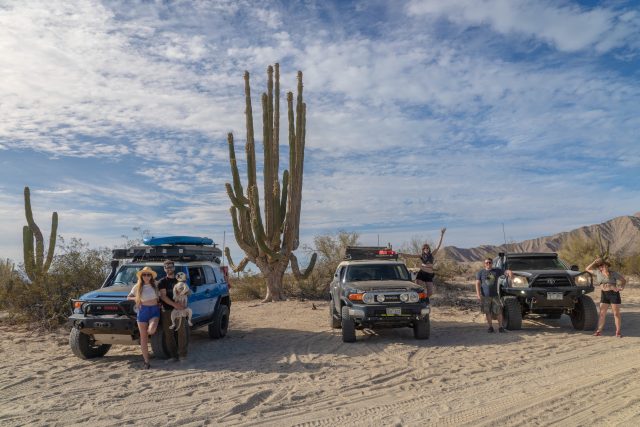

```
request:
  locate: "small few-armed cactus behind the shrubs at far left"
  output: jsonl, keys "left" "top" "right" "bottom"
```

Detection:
{"left": 22, "top": 187, "right": 58, "bottom": 281}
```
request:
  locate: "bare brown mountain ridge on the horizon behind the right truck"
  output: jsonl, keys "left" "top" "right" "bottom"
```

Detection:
{"left": 444, "top": 212, "right": 640, "bottom": 262}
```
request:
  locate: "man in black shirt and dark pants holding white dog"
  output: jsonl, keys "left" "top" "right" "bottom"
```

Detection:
{"left": 158, "top": 260, "right": 188, "bottom": 360}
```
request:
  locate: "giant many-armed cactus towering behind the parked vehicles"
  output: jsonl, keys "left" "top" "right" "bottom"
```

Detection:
{"left": 225, "top": 64, "right": 316, "bottom": 302}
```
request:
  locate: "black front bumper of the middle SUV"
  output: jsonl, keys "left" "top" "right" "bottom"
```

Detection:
{"left": 349, "top": 303, "right": 431, "bottom": 326}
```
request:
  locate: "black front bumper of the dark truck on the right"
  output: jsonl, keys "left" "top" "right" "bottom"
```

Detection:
{"left": 500, "top": 286, "right": 593, "bottom": 310}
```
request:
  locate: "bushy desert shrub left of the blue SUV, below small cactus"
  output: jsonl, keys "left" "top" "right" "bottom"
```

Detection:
{"left": 0, "top": 237, "right": 110, "bottom": 329}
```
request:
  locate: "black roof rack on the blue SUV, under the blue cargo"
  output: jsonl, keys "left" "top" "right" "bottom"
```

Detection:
{"left": 112, "top": 245, "right": 222, "bottom": 263}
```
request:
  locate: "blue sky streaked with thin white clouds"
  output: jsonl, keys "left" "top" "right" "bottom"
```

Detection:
{"left": 0, "top": 0, "right": 640, "bottom": 268}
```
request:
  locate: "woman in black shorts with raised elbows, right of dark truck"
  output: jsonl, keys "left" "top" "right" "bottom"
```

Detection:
{"left": 586, "top": 258, "right": 627, "bottom": 338}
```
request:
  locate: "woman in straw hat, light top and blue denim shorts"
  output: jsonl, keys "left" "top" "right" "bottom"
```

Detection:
{"left": 127, "top": 267, "right": 160, "bottom": 369}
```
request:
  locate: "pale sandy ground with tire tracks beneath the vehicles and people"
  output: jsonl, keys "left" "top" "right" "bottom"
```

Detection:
{"left": 0, "top": 286, "right": 640, "bottom": 426}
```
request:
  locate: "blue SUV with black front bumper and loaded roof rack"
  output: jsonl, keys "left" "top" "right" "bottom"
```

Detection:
{"left": 68, "top": 236, "right": 231, "bottom": 359}
